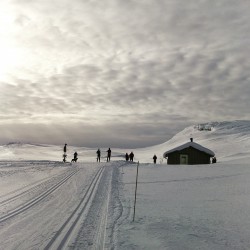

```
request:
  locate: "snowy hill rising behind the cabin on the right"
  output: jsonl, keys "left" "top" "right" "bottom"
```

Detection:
{"left": 125, "top": 121, "right": 250, "bottom": 162}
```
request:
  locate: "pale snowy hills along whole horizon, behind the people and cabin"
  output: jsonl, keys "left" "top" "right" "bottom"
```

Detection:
{"left": 0, "top": 121, "right": 250, "bottom": 163}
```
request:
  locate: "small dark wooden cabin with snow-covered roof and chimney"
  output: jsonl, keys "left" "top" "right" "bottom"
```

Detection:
{"left": 163, "top": 138, "right": 215, "bottom": 165}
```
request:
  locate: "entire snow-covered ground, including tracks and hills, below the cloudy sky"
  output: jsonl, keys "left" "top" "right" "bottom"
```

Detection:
{"left": 0, "top": 121, "right": 250, "bottom": 250}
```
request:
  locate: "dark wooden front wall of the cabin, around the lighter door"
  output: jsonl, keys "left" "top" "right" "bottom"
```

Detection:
{"left": 168, "top": 147, "right": 210, "bottom": 165}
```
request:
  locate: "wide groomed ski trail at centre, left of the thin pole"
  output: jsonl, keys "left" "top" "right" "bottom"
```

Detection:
{"left": 44, "top": 163, "right": 126, "bottom": 250}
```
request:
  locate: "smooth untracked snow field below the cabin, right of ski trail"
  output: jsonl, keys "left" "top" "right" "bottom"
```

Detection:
{"left": 117, "top": 164, "right": 250, "bottom": 250}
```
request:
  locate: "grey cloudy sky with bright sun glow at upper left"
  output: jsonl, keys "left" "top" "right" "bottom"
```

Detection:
{"left": 0, "top": 0, "right": 250, "bottom": 148}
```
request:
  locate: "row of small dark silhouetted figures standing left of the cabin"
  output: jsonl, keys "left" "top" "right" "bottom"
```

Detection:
{"left": 63, "top": 143, "right": 157, "bottom": 164}
